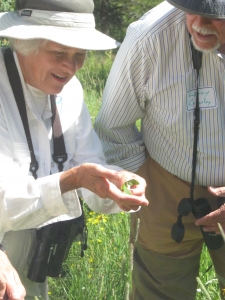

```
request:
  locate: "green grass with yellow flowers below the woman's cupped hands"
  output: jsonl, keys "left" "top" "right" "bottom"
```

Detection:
{"left": 49, "top": 209, "right": 130, "bottom": 300}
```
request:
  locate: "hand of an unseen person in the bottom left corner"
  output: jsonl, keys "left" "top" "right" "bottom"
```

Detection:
{"left": 0, "top": 251, "right": 26, "bottom": 300}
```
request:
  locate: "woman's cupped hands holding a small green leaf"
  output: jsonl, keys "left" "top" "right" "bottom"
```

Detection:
{"left": 60, "top": 163, "right": 148, "bottom": 211}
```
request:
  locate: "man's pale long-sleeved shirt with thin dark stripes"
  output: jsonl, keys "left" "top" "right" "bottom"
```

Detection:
{"left": 95, "top": 2, "right": 225, "bottom": 186}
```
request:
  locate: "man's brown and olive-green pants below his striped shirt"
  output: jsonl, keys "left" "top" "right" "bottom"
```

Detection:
{"left": 131, "top": 157, "right": 225, "bottom": 300}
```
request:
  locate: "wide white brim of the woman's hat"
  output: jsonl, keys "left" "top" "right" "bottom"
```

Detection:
{"left": 0, "top": 12, "right": 120, "bottom": 50}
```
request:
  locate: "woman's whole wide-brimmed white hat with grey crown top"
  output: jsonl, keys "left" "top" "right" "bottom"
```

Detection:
{"left": 0, "top": 0, "right": 120, "bottom": 50}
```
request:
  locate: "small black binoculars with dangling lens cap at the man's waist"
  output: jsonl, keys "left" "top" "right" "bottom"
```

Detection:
{"left": 171, "top": 197, "right": 225, "bottom": 250}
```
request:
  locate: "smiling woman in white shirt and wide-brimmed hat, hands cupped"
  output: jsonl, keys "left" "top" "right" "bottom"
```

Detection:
{"left": 0, "top": 0, "right": 148, "bottom": 299}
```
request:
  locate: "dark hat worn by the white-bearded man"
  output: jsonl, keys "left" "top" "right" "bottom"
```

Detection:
{"left": 167, "top": 0, "right": 225, "bottom": 19}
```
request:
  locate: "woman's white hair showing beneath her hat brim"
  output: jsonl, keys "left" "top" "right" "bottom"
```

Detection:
{"left": 9, "top": 38, "right": 47, "bottom": 56}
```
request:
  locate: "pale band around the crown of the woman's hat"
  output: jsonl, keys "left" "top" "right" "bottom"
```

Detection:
{"left": 18, "top": 8, "right": 95, "bottom": 28}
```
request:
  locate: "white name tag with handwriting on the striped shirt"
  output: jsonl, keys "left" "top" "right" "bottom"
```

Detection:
{"left": 186, "top": 87, "right": 217, "bottom": 111}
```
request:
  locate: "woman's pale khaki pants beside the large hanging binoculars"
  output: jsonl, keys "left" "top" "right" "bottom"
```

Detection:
{"left": 2, "top": 229, "right": 48, "bottom": 300}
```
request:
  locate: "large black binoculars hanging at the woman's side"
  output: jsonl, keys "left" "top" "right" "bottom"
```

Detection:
{"left": 27, "top": 215, "right": 87, "bottom": 283}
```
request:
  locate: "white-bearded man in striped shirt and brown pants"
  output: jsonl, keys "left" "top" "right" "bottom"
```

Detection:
{"left": 95, "top": 0, "right": 225, "bottom": 300}
